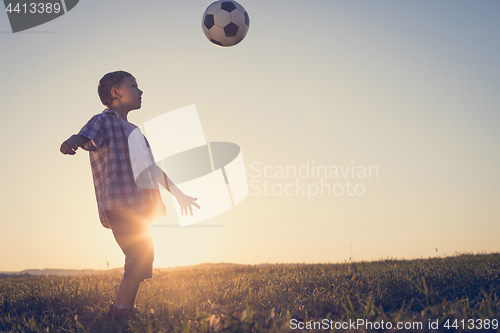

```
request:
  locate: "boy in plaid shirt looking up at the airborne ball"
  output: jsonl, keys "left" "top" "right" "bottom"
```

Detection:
{"left": 60, "top": 71, "right": 200, "bottom": 318}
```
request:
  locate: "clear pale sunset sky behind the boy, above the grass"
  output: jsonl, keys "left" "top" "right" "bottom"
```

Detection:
{"left": 0, "top": 0, "right": 500, "bottom": 271}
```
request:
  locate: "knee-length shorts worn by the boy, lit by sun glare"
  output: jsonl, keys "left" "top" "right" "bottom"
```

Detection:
{"left": 105, "top": 210, "right": 154, "bottom": 281}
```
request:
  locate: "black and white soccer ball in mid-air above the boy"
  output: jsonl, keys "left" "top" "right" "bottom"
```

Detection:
{"left": 201, "top": 0, "right": 250, "bottom": 46}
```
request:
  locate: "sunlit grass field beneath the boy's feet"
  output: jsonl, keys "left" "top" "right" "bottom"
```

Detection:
{"left": 0, "top": 254, "right": 500, "bottom": 332}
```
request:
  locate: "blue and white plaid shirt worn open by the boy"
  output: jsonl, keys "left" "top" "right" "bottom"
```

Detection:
{"left": 78, "top": 109, "right": 166, "bottom": 229}
